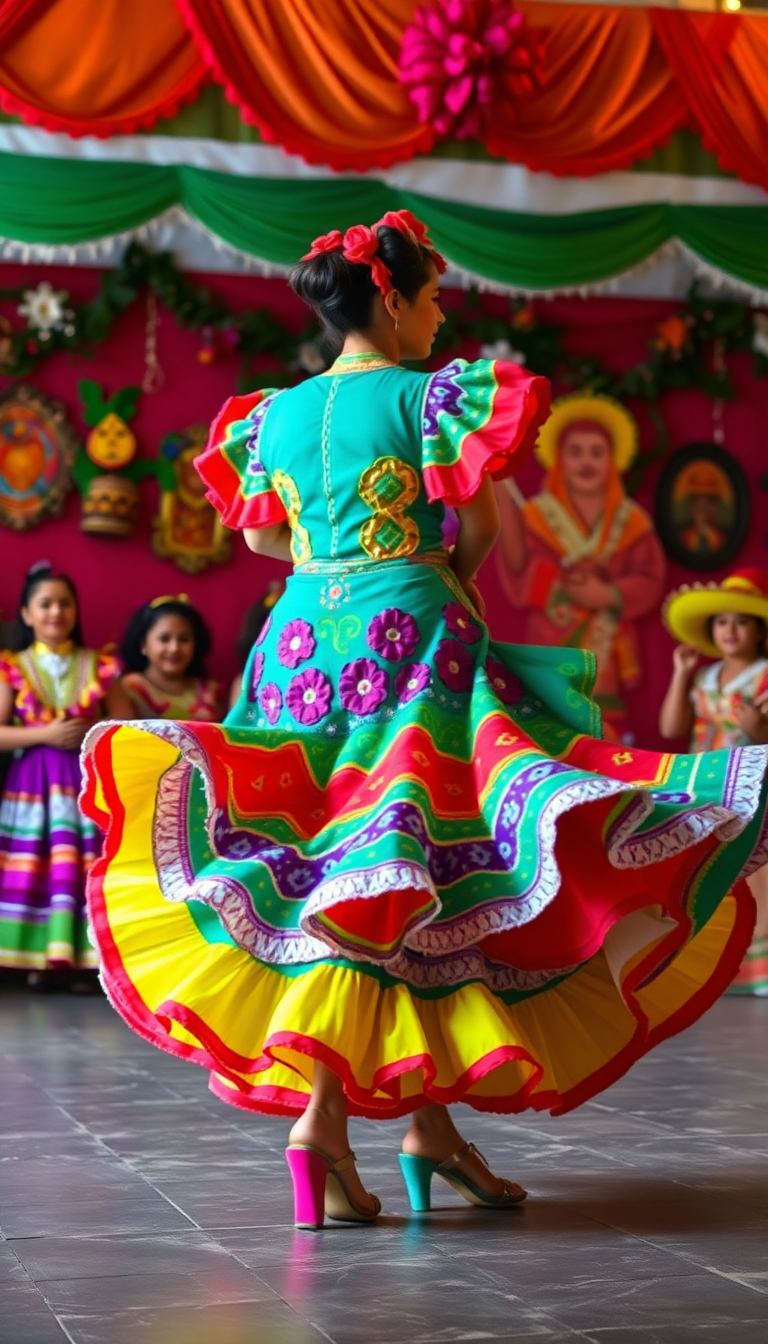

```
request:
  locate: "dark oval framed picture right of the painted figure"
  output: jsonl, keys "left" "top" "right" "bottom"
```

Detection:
{"left": 656, "top": 444, "right": 749, "bottom": 570}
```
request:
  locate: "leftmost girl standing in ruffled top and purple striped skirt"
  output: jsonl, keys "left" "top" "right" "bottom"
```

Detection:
{"left": 0, "top": 562, "right": 130, "bottom": 989}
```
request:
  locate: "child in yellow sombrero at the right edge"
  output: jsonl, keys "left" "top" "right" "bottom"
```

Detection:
{"left": 659, "top": 569, "right": 768, "bottom": 996}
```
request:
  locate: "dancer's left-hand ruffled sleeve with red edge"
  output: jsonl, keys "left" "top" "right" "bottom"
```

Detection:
{"left": 195, "top": 388, "right": 286, "bottom": 528}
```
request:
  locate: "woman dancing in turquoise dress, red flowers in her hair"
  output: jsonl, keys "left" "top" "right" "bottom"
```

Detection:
{"left": 83, "top": 211, "right": 768, "bottom": 1227}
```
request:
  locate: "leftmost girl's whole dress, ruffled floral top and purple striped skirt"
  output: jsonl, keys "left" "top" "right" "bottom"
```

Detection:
{"left": 0, "top": 644, "right": 120, "bottom": 969}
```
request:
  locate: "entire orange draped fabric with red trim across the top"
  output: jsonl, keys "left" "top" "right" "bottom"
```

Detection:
{"left": 0, "top": 0, "right": 768, "bottom": 190}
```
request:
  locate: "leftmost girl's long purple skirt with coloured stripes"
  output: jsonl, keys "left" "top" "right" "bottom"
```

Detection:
{"left": 0, "top": 746, "right": 101, "bottom": 969}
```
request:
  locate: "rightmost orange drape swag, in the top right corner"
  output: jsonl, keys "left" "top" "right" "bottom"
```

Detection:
{"left": 651, "top": 9, "right": 768, "bottom": 187}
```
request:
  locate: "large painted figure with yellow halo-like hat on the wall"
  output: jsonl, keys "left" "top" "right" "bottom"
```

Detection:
{"left": 498, "top": 394, "right": 666, "bottom": 738}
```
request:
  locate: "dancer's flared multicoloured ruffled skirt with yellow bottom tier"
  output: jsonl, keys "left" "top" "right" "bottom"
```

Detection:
{"left": 83, "top": 553, "right": 768, "bottom": 1117}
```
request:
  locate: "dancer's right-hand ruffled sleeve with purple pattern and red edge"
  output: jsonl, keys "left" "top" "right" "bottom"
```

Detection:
{"left": 421, "top": 359, "right": 549, "bottom": 508}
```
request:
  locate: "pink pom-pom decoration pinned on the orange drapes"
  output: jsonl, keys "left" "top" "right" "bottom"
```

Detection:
{"left": 399, "top": 0, "right": 543, "bottom": 140}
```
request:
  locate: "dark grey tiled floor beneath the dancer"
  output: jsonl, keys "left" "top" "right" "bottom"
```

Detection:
{"left": 0, "top": 984, "right": 768, "bottom": 1344}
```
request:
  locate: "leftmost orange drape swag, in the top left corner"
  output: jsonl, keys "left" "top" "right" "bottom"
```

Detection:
{"left": 0, "top": 0, "right": 208, "bottom": 136}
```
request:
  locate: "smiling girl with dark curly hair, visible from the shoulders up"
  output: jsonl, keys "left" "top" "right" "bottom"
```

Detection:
{"left": 120, "top": 593, "right": 221, "bottom": 723}
